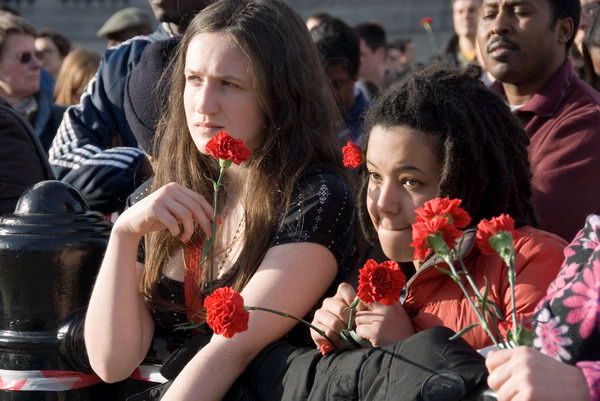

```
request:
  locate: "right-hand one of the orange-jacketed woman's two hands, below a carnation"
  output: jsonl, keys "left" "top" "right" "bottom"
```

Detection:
{"left": 355, "top": 302, "right": 415, "bottom": 347}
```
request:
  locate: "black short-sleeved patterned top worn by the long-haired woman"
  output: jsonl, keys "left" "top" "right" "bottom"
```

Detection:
{"left": 128, "top": 165, "right": 356, "bottom": 345}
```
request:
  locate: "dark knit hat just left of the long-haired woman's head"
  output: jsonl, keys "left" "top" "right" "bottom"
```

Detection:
{"left": 123, "top": 36, "right": 181, "bottom": 156}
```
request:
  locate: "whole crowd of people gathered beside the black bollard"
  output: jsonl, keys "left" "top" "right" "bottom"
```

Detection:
{"left": 0, "top": 0, "right": 600, "bottom": 401}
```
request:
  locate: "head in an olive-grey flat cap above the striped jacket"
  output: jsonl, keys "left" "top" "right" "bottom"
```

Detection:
{"left": 96, "top": 7, "right": 153, "bottom": 47}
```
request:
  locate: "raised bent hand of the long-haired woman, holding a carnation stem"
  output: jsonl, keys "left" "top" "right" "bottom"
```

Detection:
{"left": 113, "top": 183, "right": 213, "bottom": 242}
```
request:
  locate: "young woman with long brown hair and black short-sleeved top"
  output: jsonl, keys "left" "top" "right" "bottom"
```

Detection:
{"left": 85, "top": 0, "right": 353, "bottom": 400}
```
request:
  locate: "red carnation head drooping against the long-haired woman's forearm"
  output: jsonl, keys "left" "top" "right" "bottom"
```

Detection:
{"left": 204, "top": 287, "right": 250, "bottom": 338}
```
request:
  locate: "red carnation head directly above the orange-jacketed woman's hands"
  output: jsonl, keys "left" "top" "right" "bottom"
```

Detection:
{"left": 357, "top": 259, "right": 406, "bottom": 305}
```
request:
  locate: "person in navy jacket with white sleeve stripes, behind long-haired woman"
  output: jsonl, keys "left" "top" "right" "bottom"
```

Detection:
{"left": 49, "top": 0, "right": 214, "bottom": 214}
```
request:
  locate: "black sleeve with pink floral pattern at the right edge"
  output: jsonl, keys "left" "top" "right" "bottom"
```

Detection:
{"left": 533, "top": 215, "right": 600, "bottom": 401}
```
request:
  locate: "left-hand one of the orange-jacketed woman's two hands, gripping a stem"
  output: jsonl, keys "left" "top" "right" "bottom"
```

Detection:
{"left": 310, "top": 283, "right": 365, "bottom": 349}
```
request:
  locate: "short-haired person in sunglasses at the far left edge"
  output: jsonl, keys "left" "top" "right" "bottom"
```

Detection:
{"left": 0, "top": 13, "right": 65, "bottom": 151}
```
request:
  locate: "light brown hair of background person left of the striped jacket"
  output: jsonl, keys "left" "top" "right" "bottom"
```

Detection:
{"left": 54, "top": 49, "right": 100, "bottom": 105}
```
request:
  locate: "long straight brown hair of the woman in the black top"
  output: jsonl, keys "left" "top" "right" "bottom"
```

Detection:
{"left": 142, "top": 0, "right": 340, "bottom": 299}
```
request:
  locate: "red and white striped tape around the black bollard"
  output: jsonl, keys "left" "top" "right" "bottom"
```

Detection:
{"left": 0, "top": 365, "right": 167, "bottom": 391}
